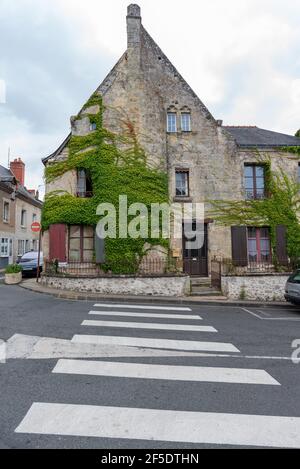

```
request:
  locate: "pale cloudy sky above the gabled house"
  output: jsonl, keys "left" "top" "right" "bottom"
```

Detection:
{"left": 0, "top": 0, "right": 300, "bottom": 192}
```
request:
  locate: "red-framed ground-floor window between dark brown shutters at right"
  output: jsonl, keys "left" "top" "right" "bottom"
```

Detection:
{"left": 248, "top": 227, "right": 272, "bottom": 263}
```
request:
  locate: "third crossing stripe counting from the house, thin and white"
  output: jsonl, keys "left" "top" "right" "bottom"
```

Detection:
{"left": 81, "top": 321, "right": 218, "bottom": 332}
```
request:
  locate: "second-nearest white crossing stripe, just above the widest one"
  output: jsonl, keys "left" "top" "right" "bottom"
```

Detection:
{"left": 53, "top": 360, "right": 280, "bottom": 386}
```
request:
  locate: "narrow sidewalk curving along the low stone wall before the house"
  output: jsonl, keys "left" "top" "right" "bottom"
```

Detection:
{"left": 19, "top": 279, "right": 293, "bottom": 308}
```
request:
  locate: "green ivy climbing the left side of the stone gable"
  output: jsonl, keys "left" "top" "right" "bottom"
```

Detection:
{"left": 42, "top": 93, "right": 169, "bottom": 274}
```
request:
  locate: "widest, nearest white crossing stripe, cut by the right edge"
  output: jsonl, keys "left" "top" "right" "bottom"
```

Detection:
{"left": 15, "top": 403, "right": 300, "bottom": 448}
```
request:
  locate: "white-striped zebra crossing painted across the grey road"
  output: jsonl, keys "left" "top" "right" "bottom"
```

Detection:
{"left": 15, "top": 303, "right": 300, "bottom": 448}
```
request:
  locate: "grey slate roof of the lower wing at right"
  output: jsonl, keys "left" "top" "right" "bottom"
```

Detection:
{"left": 223, "top": 126, "right": 300, "bottom": 148}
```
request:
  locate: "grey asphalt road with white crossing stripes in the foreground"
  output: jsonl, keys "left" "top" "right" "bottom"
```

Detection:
{"left": 0, "top": 285, "right": 300, "bottom": 449}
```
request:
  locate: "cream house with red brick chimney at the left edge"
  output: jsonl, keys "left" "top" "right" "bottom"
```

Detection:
{"left": 0, "top": 158, "right": 43, "bottom": 269}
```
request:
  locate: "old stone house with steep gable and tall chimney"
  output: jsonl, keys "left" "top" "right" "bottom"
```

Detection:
{"left": 43, "top": 5, "right": 300, "bottom": 296}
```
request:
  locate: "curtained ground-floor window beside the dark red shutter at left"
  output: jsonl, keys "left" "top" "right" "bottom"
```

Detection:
{"left": 69, "top": 225, "right": 95, "bottom": 262}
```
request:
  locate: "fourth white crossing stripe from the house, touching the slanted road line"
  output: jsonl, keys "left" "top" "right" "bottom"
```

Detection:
{"left": 71, "top": 335, "right": 240, "bottom": 353}
